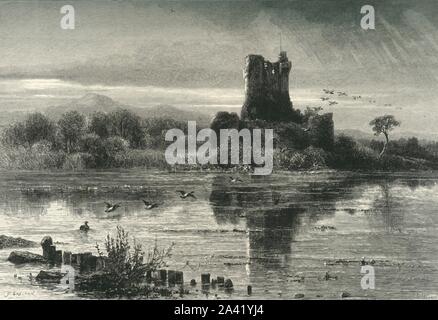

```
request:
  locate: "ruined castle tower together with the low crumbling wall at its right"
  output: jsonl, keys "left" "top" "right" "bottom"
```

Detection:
{"left": 240, "top": 51, "right": 334, "bottom": 150}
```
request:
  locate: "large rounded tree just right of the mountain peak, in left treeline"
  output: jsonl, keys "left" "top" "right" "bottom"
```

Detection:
{"left": 111, "top": 109, "right": 144, "bottom": 148}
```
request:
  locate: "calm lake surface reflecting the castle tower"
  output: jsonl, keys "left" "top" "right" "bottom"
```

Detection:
{"left": 0, "top": 170, "right": 438, "bottom": 299}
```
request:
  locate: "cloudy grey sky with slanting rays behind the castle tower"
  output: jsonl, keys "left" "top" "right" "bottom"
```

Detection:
{"left": 0, "top": 0, "right": 438, "bottom": 132}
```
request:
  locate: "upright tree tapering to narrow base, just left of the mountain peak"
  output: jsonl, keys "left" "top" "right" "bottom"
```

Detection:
{"left": 58, "top": 111, "right": 85, "bottom": 153}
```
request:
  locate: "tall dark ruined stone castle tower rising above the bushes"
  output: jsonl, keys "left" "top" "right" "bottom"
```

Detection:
{"left": 241, "top": 51, "right": 295, "bottom": 121}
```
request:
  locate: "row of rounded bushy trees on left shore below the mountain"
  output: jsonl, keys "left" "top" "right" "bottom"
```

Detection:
{"left": 2, "top": 109, "right": 186, "bottom": 153}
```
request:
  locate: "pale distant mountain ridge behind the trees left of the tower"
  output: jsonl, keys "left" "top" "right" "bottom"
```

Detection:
{"left": 45, "top": 93, "right": 211, "bottom": 126}
